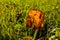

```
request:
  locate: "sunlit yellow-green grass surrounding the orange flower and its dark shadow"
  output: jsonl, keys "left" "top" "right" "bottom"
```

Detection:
{"left": 0, "top": 0, "right": 60, "bottom": 40}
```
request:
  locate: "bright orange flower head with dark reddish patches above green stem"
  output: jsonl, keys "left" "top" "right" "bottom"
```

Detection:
{"left": 27, "top": 9, "right": 44, "bottom": 29}
